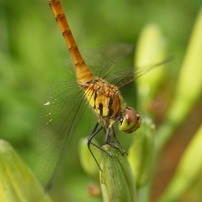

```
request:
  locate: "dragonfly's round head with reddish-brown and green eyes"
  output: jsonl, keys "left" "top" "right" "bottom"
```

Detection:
{"left": 119, "top": 107, "right": 142, "bottom": 133}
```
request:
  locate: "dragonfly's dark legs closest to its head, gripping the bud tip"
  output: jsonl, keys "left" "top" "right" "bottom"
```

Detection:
{"left": 106, "top": 126, "right": 127, "bottom": 156}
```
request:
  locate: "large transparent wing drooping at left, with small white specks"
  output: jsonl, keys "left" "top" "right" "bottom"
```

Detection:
{"left": 36, "top": 82, "right": 87, "bottom": 189}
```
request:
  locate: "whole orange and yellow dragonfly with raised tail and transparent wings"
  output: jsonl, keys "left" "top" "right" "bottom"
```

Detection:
{"left": 36, "top": 0, "right": 170, "bottom": 190}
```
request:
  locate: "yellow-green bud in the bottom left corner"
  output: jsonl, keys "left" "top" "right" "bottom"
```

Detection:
{"left": 0, "top": 140, "right": 51, "bottom": 202}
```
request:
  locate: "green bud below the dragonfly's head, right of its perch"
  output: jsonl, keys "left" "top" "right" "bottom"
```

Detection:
{"left": 128, "top": 118, "right": 155, "bottom": 188}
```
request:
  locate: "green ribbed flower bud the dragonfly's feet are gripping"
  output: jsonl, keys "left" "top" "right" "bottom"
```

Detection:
{"left": 100, "top": 145, "right": 136, "bottom": 202}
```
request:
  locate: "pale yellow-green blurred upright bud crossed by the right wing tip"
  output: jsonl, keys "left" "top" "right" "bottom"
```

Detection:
{"left": 134, "top": 24, "right": 167, "bottom": 104}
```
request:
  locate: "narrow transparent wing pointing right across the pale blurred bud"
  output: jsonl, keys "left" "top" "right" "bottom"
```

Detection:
{"left": 105, "top": 57, "right": 173, "bottom": 88}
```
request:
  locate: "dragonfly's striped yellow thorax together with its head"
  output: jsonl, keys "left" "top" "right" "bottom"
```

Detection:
{"left": 80, "top": 77, "right": 141, "bottom": 133}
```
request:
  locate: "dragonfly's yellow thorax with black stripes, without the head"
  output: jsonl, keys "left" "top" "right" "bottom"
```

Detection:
{"left": 83, "top": 77, "right": 122, "bottom": 119}
